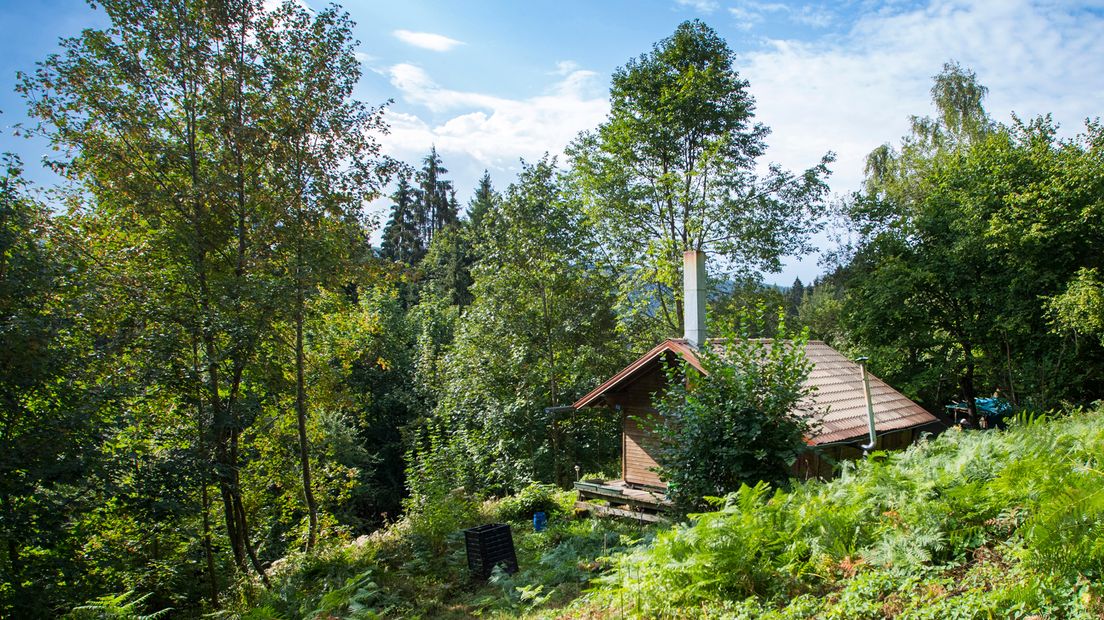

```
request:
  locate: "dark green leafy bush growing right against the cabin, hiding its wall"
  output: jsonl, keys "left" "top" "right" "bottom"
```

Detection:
{"left": 654, "top": 314, "right": 810, "bottom": 511}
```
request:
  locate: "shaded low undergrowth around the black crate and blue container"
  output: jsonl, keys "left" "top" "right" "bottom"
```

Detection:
{"left": 230, "top": 484, "right": 654, "bottom": 620}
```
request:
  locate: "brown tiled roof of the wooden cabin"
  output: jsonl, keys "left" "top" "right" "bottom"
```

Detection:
{"left": 573, "top": 339, "right": 938, "bottom": 446}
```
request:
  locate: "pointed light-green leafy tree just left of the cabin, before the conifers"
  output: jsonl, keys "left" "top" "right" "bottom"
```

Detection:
{"left": 410, "top": 158, "right": 626, "bottom": 494}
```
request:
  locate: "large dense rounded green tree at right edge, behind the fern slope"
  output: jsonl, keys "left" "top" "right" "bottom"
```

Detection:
{"left": 837, "top": 63, "right": 1102, "bottom": 409}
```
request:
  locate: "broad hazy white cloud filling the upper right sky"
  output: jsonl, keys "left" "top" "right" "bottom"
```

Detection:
{"left": 740, "top": 0, "right": 1104, "bottom": 198}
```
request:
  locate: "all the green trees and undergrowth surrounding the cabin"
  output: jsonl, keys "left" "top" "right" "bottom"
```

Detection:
{"left": 0, "top": 0, "right": 1104, "bottom": 618}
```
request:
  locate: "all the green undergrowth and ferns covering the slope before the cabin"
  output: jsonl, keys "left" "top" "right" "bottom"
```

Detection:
{"left": 228, "top": 408, "right": 1104, "bottom": 620}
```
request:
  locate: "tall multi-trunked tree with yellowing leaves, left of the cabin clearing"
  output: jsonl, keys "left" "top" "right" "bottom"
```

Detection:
{"left": 20, "top": 0, "right": 393, "bottom": 606}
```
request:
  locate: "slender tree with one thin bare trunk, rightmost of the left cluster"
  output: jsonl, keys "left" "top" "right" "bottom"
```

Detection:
{"left": 257, "top": 2, "right": 385, "bottom": 549}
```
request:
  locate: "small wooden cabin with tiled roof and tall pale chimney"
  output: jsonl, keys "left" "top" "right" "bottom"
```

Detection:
{"left": 572, "top": 252, "right": 942, "bottom": 512}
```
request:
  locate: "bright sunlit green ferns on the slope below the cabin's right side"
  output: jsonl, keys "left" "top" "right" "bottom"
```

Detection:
{"left": 592, "top": 408, "right": 1104, "bottom": 618}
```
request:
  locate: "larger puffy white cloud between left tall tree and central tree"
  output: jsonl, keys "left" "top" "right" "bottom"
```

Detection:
{"left": 382, "top": 63, "right": 609, "bottom": 171}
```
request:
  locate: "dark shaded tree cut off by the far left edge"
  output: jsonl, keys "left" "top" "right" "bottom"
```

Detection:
{"left": 0, "top": 154, "right": 104, "bottom": 618}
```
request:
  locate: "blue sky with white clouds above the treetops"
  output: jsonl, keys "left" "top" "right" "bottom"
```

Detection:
{"left": 0, "top": 0, "right": 1104, "bottom": 285}
